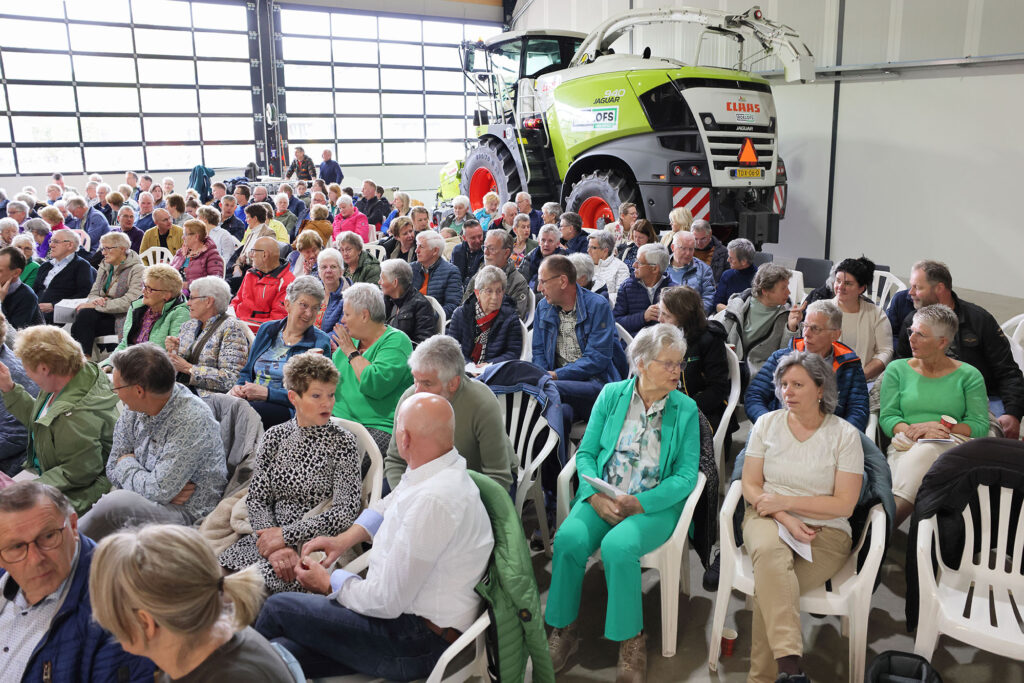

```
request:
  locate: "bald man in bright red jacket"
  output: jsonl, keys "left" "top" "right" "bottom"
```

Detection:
{"left": 231, "top": 238, "right": 295, "bottom": 333}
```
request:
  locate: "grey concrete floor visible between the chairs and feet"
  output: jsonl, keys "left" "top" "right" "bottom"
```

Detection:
{"left": 534, "top": 280, "right": 1024, "bottom": 683}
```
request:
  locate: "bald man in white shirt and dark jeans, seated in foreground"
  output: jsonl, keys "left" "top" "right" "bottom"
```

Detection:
{"left": 256, "top": 393, "right": 494, "bottom": 680}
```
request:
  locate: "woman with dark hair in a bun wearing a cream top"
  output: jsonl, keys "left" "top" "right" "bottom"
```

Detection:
{"left": 833, "top": 256, "right": 893, "bottom": 382}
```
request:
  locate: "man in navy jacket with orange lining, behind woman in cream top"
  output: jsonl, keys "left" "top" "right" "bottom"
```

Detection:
{"left": 743, "top": 300, "right": 870, "bottom": 431}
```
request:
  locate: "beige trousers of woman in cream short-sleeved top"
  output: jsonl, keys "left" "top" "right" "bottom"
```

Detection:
{"left": 743, "top": 506, "right": 852, "bottom": 683}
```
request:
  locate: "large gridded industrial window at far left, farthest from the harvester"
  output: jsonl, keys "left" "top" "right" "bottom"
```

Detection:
{"left": 0, "top": 0, "right": 255, "bottom": 175}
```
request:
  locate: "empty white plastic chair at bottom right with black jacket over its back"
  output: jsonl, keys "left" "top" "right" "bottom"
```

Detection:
{"left": 913, "top": 484, "right": 1024, "bottom": 660}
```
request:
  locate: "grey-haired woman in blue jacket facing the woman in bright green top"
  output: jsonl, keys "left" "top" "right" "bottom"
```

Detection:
{"left": 228, "top": 275, "right": 331, "bottom": 429}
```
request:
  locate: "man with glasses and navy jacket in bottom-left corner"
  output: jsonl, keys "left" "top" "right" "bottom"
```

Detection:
{"left": 0, "top": 481, "right": 154, "bottom": 681}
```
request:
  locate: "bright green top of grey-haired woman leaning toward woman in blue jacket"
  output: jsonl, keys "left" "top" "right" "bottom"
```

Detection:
{"left": 334, "top": 327, "right": 413, "bottom": 434}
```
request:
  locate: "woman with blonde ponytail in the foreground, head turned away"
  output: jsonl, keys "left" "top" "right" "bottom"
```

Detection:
{"left": 89, "top": 524, "right": 295, "bottom": 683}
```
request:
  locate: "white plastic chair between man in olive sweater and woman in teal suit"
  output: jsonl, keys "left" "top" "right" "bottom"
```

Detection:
{"left": 498, "top": 391, "right": 558, "bottom": 550}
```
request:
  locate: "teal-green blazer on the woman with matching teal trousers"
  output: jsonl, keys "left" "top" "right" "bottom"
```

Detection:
{"left": 575, "top": 378, "right": 700, "bottom": 512}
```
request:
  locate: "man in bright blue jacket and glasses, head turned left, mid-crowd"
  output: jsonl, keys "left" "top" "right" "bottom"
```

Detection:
{"left": 534, "top": 254, "right": 623, "bottom": 421}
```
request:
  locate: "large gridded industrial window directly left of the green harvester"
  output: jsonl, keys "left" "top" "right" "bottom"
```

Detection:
{"left": 281, "top": 5, "right": 501, "bottom": 171}
